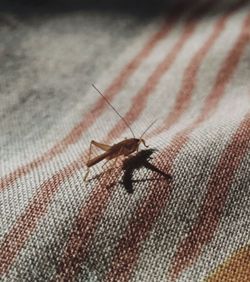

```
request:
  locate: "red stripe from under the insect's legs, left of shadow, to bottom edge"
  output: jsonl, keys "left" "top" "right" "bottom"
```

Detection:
{"left": 55, "top": 169, "right": 121, "bottom": 281}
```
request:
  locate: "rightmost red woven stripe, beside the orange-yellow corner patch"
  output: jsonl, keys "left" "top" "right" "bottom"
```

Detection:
{"left": 171, "top": 114, "right": 250, "bottom": 281}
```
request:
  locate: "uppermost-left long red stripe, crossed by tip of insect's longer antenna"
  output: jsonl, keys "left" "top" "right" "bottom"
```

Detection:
{"left": 0, "top": 11, "right": 174, "bottom": 191}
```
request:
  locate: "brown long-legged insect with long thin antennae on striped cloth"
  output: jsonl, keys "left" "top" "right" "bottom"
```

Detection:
{"left": 84, "top": 84, "right": 156, "bottom": 181}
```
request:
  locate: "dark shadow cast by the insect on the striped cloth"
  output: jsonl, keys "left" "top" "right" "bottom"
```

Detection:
{"left": 119, "top": 149, "right": 172, "bottom": 194}
